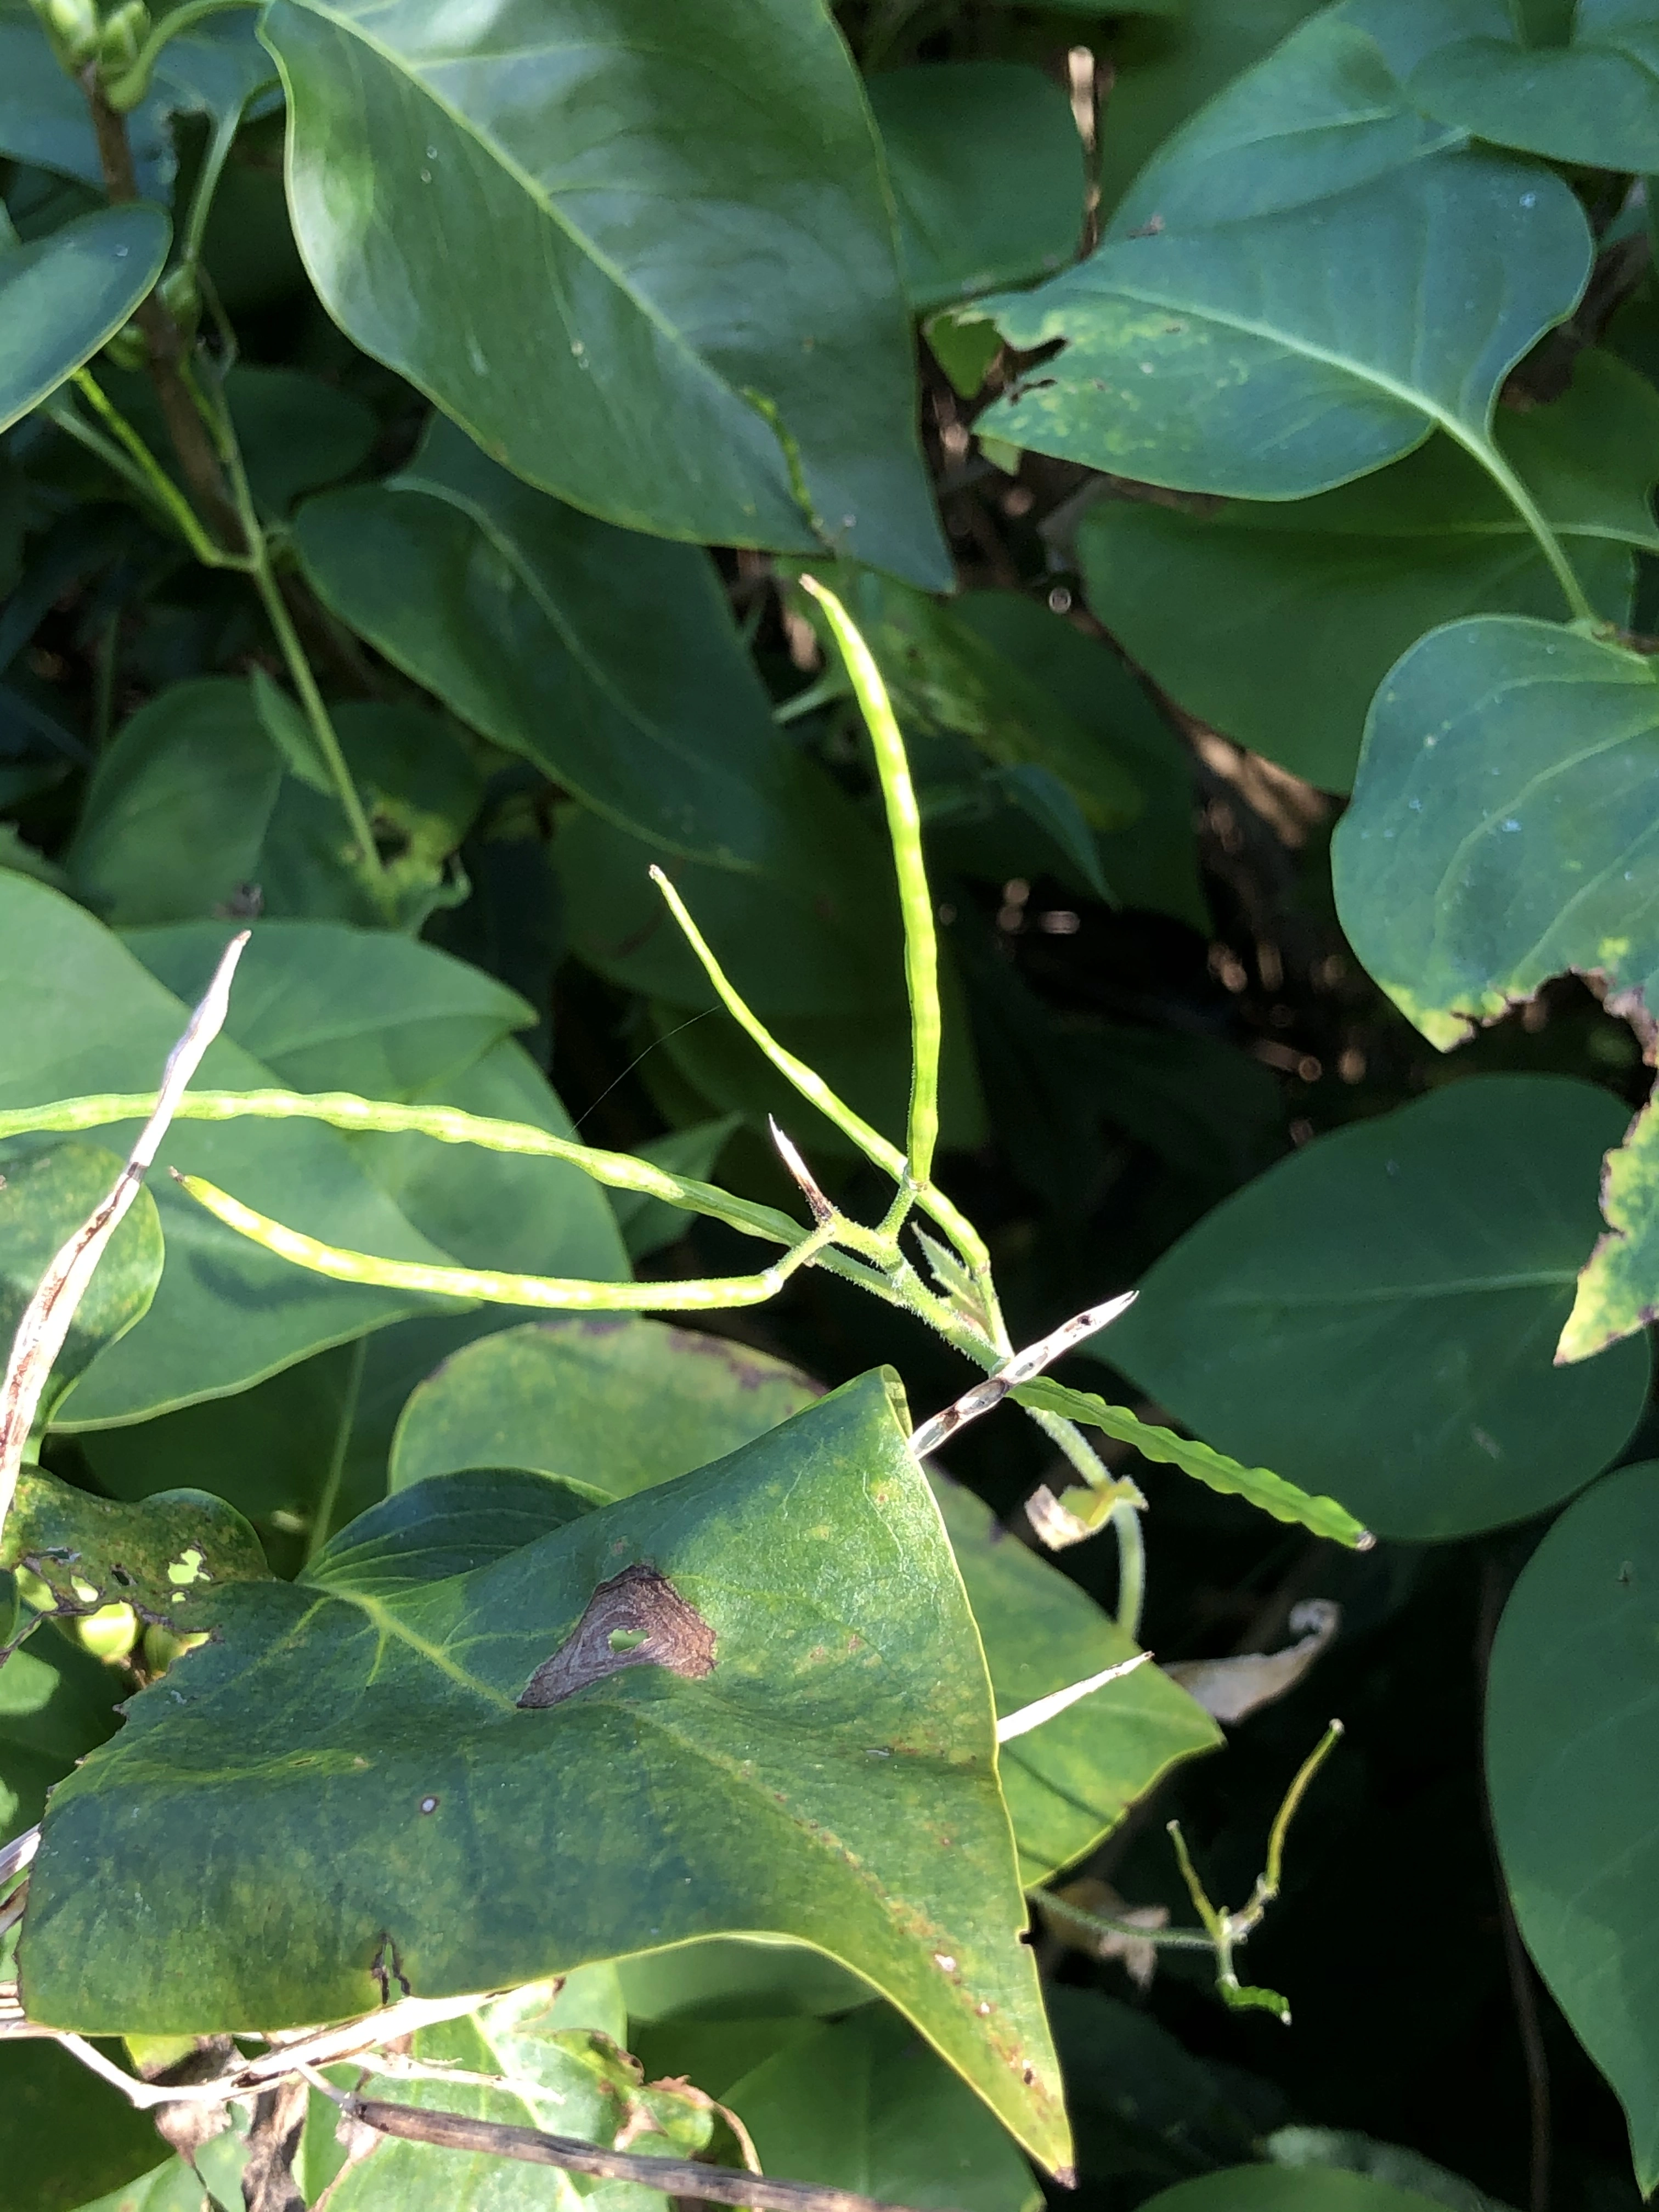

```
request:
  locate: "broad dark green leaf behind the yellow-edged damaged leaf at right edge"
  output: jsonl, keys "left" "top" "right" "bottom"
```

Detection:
{"left": 1108, "top": 1075, "right": 1648, "bottom": 1539}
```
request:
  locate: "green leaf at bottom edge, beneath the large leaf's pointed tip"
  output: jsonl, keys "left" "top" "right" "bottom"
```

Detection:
{"left": 639, "top": 2006, "right": 1042, "bottom": 2212}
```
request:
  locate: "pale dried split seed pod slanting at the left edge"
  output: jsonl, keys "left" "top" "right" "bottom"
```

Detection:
{"left": 0, "top": 929, "right": 248, "bottom": 1531}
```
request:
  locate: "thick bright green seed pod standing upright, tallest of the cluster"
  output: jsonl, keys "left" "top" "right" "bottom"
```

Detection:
{"left": 801, "top": 575, "right": 943, "bottom": 1219}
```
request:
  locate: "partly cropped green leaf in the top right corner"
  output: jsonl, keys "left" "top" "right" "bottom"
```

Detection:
{"left": 1411, "top": 0, "right": 1659, "bottom": 172}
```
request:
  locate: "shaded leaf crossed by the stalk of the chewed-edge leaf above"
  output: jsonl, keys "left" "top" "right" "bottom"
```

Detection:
{"left": 1077, "top": 352, "right": 1659, "bottom": 792}
